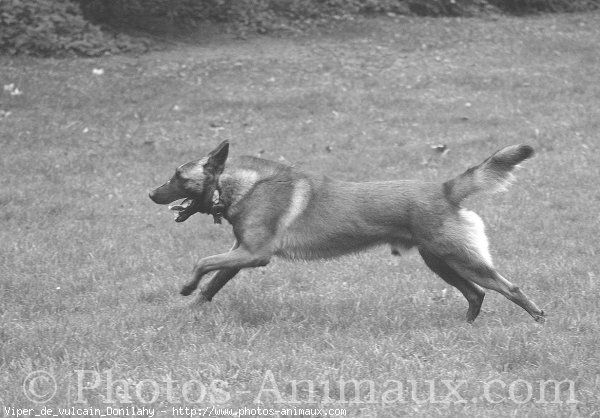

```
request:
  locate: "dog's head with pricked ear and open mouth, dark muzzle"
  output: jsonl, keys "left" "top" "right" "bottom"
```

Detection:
{"left": 150, "top": 141, "right": 229, "bottom": 211}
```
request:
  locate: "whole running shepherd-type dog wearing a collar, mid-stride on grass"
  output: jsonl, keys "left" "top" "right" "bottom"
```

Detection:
{"left": 150, "top": 141, "right": 545, "bottom": 323}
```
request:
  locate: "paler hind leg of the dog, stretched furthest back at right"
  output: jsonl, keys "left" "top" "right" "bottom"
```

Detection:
{"left": 448, "top": 260, "right": 546, "bottom": 322}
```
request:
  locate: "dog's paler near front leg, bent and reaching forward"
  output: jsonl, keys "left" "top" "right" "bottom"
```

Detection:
{"left": 181, "top": 246, "right": 272, "bottom": 296}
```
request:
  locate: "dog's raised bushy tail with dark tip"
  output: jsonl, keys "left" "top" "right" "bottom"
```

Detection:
{"left": 443, "top": 145, "right": 533, "bottom": 205}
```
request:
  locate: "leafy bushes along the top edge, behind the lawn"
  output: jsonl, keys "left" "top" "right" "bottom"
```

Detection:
{"left": 0, "top": 0, "right": 600, "bottom": 56}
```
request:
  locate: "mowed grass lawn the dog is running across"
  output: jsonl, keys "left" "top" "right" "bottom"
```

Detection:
{"left": 0, "top": 14, "right": 600, "bottom": 417}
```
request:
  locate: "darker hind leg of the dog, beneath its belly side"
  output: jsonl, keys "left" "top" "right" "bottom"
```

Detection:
{"left": 419, "top": 248, "right": 485, "bottom": 323}
